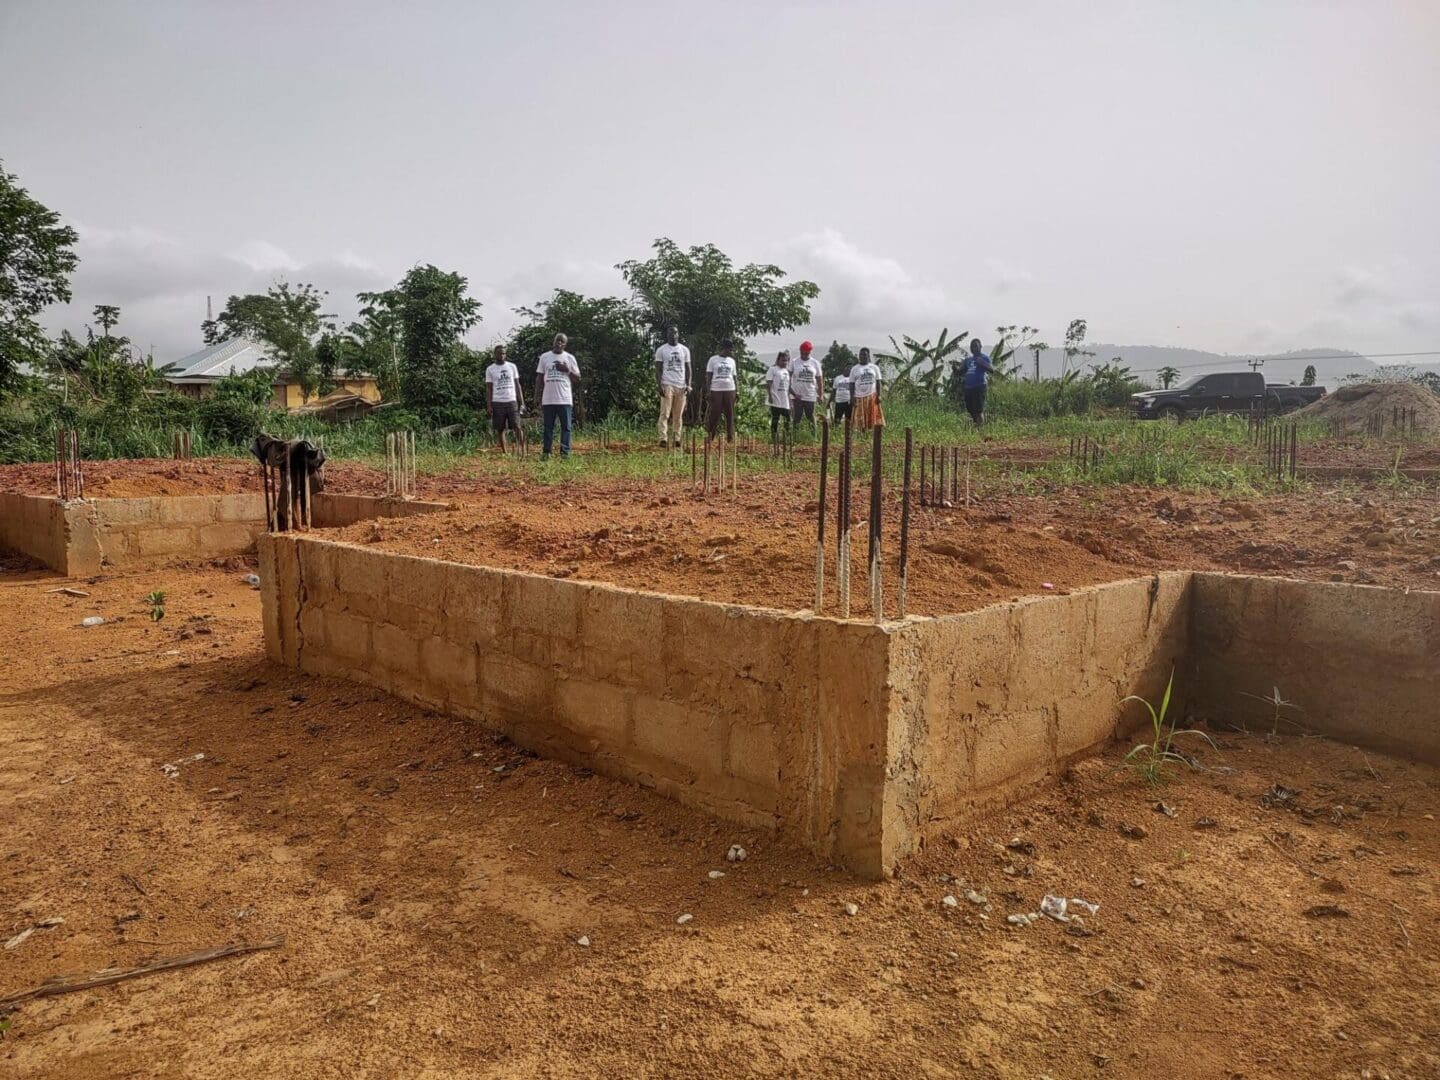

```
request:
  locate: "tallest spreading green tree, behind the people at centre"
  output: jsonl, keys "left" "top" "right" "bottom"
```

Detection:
{"left": 616, "top": 238, "right": 819, "bottom": 415}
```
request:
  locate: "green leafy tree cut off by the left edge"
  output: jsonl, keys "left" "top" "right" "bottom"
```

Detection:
{"left": 0, "top": 163, "right": 79, "bottom": 393}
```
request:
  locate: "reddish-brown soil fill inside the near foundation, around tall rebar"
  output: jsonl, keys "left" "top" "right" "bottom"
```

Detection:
{"left": 324, "top": 474, "right": 1440, "bottom": 616}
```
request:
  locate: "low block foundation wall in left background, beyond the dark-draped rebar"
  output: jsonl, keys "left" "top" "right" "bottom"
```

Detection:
{"left": 0, "top": 492, "right": 449, "bottom": 577}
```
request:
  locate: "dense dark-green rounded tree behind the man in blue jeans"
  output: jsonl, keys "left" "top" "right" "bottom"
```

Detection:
{"left": 508, "top": 289, "right": 655, "bottom": 420}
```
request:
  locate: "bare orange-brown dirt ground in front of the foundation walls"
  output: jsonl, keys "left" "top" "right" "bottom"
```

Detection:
{"left": 0, "top": 570, "right": 1440, "bottom": 1080}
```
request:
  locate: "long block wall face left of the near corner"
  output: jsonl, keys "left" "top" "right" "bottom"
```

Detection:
{"left": 259, "top": 534, "right": 888, "bottom": 876}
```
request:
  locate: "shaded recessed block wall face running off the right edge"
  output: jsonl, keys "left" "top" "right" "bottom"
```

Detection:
{"left": 1191, "top": 573, "right": 1440, "bottom": 765}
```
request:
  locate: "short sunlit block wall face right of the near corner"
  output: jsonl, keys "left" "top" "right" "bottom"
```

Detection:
{"left": 886, "top": 573, "right": 1191, "bottom": 855}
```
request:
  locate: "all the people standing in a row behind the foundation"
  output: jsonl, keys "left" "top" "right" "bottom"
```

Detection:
{"left": 485, "top": 327, "right": 995, "bottom": 456}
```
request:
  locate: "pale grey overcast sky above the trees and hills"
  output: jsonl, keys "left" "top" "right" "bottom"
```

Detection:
{"left": 0, "top": 0, "right": 1440, "bottom": 361}
